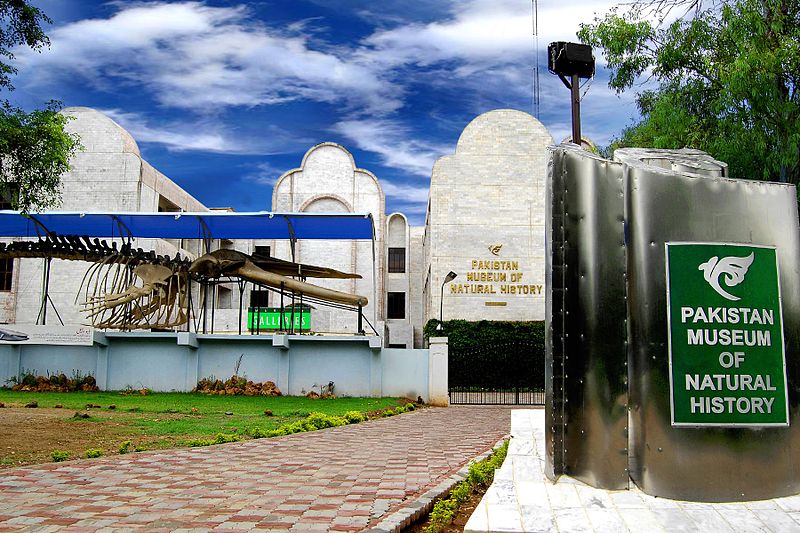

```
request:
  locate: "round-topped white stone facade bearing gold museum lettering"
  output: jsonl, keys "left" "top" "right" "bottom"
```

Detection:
{"left": 424, "top": 109, "right": 553, "bottom": 320}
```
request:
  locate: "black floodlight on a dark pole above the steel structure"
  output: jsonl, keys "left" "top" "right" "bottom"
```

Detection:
{"left": 547, "top": 41, "right": 594, "bottom": 146}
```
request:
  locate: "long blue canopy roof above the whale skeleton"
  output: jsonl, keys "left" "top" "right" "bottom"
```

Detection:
{"left": 0, "top": 211, "right": 373, "bottom": 240}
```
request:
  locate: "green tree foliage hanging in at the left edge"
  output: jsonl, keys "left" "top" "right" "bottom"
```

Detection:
{"left": 0, "top": 0, "right": 80, "bottom": 211}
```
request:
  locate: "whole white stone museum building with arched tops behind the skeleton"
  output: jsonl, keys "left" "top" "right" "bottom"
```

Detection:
{"left": 0, "top": 107, "right": 553, "bottom": 348}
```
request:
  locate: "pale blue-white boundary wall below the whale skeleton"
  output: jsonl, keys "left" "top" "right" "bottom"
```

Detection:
{"left": 0, "top": 332, "right": 447, "bottom": 405}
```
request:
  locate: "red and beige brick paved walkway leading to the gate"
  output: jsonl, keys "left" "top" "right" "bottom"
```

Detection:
{"left": 0, "top": 406, "right": 511, "bottom": 532}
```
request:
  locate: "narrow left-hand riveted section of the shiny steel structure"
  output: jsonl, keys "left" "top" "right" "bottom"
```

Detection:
{"left": 545, "top": 145, "right": 628, "bottom": 489}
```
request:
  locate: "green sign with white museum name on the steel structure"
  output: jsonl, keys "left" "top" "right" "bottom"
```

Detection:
{"left": 666, "top": 243, "right": 789, "bottom": 427}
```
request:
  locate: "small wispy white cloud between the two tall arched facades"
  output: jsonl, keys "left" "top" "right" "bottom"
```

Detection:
{"left": 334, "top": 117, "right": 453, "bottom": 177}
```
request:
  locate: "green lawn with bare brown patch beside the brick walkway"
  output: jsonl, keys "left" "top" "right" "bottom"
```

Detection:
{"left": 0, "top": 389, "right": 412, "bottom": 468}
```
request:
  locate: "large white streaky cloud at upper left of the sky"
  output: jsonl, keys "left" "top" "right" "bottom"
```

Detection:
{"left": 18, "top": 2, "right": 400, "bottom": 113}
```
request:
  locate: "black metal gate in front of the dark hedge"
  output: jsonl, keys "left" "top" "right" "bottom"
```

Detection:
{"left": 448, "top": 342, "right": 544, "bottom": 405}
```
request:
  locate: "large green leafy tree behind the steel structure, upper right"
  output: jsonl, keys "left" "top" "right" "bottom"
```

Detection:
{"left": 578, "top": 0, "right": 800, "bottom": 184}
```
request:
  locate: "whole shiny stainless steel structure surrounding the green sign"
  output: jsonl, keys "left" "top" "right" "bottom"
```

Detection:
{"left": 547, "top": 146, "right": 800, "bottom": 501}
